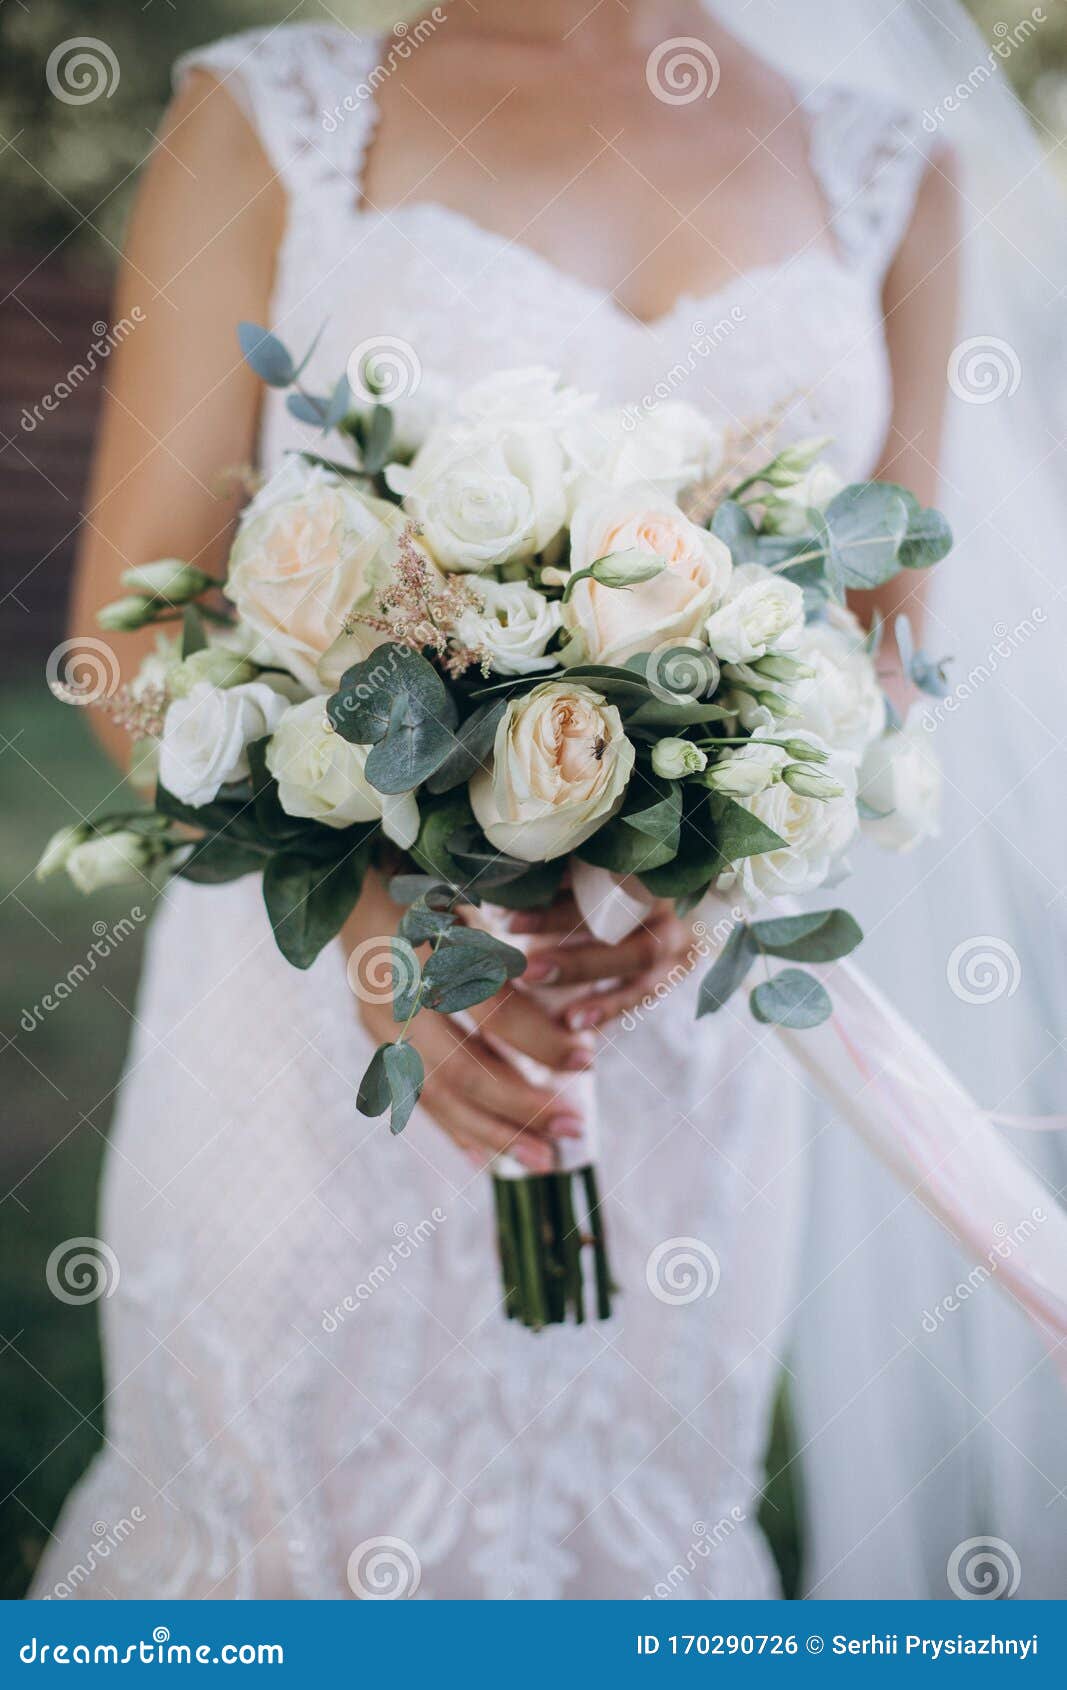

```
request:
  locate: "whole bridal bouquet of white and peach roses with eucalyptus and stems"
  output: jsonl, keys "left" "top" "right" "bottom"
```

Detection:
{"left": 41, "top": 324, "right": 950, "bottom": 1327}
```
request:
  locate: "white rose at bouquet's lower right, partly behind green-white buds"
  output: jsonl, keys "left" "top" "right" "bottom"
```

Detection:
{"left": 719, "top": 728, "right": 857, "bottom": 904}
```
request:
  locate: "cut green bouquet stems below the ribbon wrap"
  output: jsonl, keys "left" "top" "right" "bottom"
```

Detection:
{"left": 492, "top": 1164, "right": 614, "bottom": 1332}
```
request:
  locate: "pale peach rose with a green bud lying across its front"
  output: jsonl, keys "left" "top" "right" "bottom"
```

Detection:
{"left": 563, "top": 487, "right": 732, "bottom": 664}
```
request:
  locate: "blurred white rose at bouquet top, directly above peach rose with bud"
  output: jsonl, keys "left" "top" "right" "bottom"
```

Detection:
{"left": 563, "top": 401, "right": 722, "bottom": 510}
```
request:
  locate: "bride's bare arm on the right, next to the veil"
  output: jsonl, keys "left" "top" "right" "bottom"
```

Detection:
{"left": 851, "top": 154, "right": 959, "bottom": 690}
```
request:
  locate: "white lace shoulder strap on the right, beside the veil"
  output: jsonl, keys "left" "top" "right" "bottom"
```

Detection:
{"left": 803, "top": 88, "right": 930, "bottom": 281}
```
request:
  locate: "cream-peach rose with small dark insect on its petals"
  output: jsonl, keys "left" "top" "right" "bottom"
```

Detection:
{"left": 470, "top": 681, "right": 634, "bottom": 862}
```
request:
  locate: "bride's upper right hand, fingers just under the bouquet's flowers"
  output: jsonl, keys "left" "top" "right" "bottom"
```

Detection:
{"left": 509, "top": 894, "right": 703, "bottom": 1033}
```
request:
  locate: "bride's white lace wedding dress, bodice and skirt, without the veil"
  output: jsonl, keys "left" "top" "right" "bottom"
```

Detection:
{"left": 36, "top": 25, "right": 923, "bottom": 1599}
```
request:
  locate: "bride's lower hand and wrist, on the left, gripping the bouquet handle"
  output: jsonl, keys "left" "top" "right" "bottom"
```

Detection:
{"left": 342, "top": 874, "right": 592, "bottom": 1173}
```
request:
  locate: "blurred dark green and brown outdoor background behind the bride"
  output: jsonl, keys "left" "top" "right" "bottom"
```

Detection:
{"left": 0, "top": 0, "right": 1067, "bottom": 1597}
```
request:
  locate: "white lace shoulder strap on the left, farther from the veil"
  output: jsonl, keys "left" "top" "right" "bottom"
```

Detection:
{"left": 172, "top": 24, "right": 388, "bottom": 210}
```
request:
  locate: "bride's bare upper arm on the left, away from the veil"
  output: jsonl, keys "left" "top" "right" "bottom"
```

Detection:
{"left": 71, "top": 73, "right": 284, "bottom": 761}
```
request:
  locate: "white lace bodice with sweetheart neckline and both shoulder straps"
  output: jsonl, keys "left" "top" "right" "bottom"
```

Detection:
{"left": 178, "top": 24, "right": 925, "bottom": 490}
